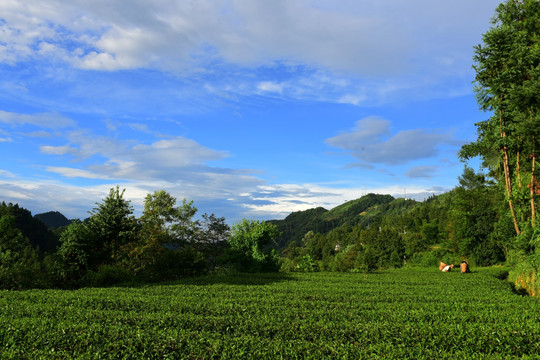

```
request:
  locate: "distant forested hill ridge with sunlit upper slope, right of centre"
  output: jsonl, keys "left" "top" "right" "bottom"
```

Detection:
{"left": 269, "top": 194, "right": 410, "bottom": 249}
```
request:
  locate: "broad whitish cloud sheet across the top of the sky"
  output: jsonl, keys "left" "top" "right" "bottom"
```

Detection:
{"left": 0, "top": 0, "right": 499, "bottom": 105}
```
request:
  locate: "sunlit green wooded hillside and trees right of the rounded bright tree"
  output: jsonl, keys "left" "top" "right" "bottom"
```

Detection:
{"left": 274, "top": 167, "right": 518, "bottom": 271}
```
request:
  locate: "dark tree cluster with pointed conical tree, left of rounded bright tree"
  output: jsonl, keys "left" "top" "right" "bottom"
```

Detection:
{"left": 47, "top": 187, "right": 220, "bottom": 288}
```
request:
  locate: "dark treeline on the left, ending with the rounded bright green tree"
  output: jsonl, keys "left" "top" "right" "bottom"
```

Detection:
{"left": 0, "top": 187, "right": 279, "bottom": 289}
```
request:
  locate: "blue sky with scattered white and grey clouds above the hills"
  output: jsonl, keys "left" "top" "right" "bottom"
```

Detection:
{"left": 0, "top": 0, "right": 500, "bottom": 222}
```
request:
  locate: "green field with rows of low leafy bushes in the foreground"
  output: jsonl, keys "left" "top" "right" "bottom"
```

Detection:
{"left": 0, "top": 269, "right": 540, "bottom": 359}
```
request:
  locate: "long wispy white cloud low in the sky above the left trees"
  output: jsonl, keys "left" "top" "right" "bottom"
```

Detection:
{"left": 40, "top": 130, "right": 246, "bottom": 193}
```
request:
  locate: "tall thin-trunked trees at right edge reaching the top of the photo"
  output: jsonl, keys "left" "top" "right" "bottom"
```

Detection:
{"left": 460, "top": 0, "right": 540, "bottom": 235}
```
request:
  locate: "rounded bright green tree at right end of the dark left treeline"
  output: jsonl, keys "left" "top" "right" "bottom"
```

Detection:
{"left": 228, "top": 219, "right": 279, "bottom": 272}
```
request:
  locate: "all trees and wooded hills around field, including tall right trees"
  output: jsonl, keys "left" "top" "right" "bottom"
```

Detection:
{"left": 0, "top": 0, "right": 540, "bottom": 293}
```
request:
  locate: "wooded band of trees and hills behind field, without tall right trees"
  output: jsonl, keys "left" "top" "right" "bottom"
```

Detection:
{"left": 0, "top": 167, "right": 535, "bottom": 289}
